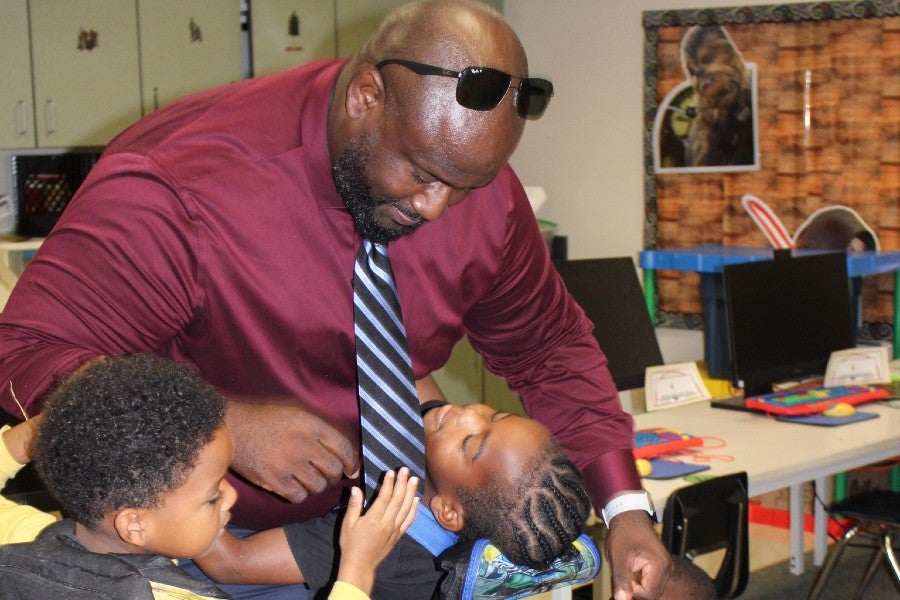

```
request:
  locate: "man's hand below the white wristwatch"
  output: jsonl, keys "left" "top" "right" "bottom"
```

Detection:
{"left": 606, "top": 510, "right": 673, "bottom": 600}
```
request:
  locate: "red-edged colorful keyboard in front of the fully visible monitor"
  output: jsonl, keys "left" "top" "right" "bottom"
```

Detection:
{"left": 744, "top": 385, "right": 890, "bottom": 415}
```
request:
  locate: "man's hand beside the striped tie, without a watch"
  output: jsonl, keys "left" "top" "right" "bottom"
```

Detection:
{"left": 225, "top": 400, "right": 359, "bottom": 502}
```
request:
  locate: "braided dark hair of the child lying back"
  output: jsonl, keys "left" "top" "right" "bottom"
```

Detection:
{"left": 459, "top": 439, "right": 591, "bottom": 569}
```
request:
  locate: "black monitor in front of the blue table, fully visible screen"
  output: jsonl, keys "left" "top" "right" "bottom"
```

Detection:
{"left": 722, "top": 252, "right": 854, "bottom": 396}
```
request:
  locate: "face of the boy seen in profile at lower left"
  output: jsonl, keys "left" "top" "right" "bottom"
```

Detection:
{"left": 147, "top": 427, "right": 237, "bottom": 558}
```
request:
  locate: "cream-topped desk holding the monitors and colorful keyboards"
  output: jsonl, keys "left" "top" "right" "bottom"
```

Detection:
{"left": 634, "top": 402, "right": 900, "bottom": 575}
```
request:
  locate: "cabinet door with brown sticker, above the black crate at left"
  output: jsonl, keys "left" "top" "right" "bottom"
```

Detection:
{"left": 29, "top": 0, "right": 141, "bottom": 147}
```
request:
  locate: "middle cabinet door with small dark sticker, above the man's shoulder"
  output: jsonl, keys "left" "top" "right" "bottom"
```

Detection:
{"left": 138, "top": 0, "right": 243, "bottom": 114}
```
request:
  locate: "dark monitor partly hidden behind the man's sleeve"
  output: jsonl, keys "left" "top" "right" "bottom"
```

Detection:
{"left": 554, "top": 256, "right": 663, "bottom": 390}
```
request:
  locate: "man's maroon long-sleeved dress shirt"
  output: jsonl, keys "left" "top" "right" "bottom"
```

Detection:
{"left": 0, "top": 61, "right": 640, "bottom": 528}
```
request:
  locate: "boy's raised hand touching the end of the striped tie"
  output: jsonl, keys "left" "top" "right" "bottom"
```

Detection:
{"left": 337, "top": 467, "right": 419, "bottom": 594}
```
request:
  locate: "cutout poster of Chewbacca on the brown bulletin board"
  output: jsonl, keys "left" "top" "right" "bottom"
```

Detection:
{"left": 653, "top": 25, "right": 759, "bottom": 173}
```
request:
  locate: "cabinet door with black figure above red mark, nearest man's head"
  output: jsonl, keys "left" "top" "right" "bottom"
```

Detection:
{"left": 250, "top": 0, "right": 337, "bottom": 77}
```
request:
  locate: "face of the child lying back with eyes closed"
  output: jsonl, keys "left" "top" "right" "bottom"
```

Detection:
{"left": 423, "top": 404, "right": 550, "bottom": 498}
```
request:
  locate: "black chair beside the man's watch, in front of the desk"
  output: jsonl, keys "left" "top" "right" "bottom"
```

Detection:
{"left": 662, "top": 471, "right": 750, "bottom": 598}
